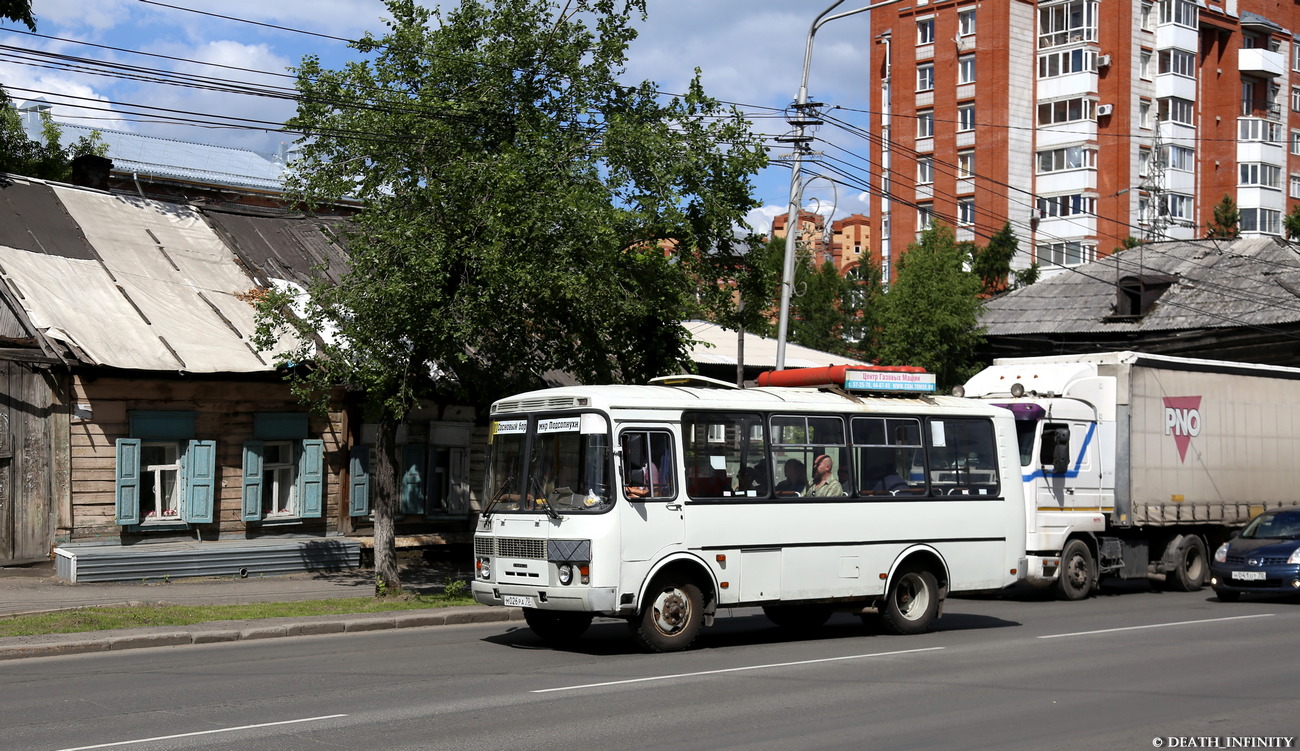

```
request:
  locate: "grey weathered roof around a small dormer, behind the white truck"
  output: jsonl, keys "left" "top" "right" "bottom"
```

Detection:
{"left": 980, "top": 236, "right": 1300, "bottom": 335}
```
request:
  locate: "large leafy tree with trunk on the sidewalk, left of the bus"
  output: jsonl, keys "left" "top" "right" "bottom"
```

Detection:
{"left": 261, "top": 0, "right": 767, "bottom": 592}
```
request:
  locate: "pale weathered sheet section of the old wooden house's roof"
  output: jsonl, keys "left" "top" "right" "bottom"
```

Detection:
{"left": 0, "top": 178, "right": 287, "bottom": 373}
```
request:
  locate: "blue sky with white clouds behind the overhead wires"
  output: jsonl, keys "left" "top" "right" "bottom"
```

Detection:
{"left": 0, "top": 0, "right": 870, "bottom": 231}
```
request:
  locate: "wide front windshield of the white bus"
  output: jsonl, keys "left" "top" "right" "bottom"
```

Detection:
{"left": 484, "top": 413, "right": 614, "bottom": 515}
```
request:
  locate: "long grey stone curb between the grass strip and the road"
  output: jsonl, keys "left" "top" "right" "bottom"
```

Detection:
{"left": 0, "top": 605, "right": 524, "bottom": 660}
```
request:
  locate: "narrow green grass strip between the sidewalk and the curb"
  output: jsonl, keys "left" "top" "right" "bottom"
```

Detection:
{"left": 0, "top": 595, "right": 475, "bottom": 637}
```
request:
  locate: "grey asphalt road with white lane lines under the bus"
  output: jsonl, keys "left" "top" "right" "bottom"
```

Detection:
{"left": 0, "top": 590, "right": 1300, "bottom": 751}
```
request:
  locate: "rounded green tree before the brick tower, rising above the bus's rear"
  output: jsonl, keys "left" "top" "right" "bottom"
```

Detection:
{"left": 879, "top": 222, "right": 982, "bottom": 390}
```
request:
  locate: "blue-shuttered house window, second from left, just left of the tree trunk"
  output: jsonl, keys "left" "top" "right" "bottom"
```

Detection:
{"left": 241, "top": 412, "right": 325, "bottom": 521}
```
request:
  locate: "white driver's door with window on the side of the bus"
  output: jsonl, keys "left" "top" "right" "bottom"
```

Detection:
{"left": 619, "top": 426, "right": 686, "bottom": 561}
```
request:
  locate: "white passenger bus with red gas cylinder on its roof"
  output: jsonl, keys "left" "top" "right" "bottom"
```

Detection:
{"left": 472, "top": 368, "right": 1024, "bottom": 651}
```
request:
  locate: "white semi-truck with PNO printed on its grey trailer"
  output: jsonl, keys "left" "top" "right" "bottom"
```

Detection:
{"left": 957, "top": 352, "right": 1300, "bottom": 599}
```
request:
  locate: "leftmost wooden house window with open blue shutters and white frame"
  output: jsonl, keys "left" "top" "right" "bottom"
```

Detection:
{"left": 114, "top": 409, "right": 216, "bottom": 529}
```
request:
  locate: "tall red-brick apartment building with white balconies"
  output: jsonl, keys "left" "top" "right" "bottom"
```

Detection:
{"left": 867, "top": 0, "right": 1300, "bottom": 278}
